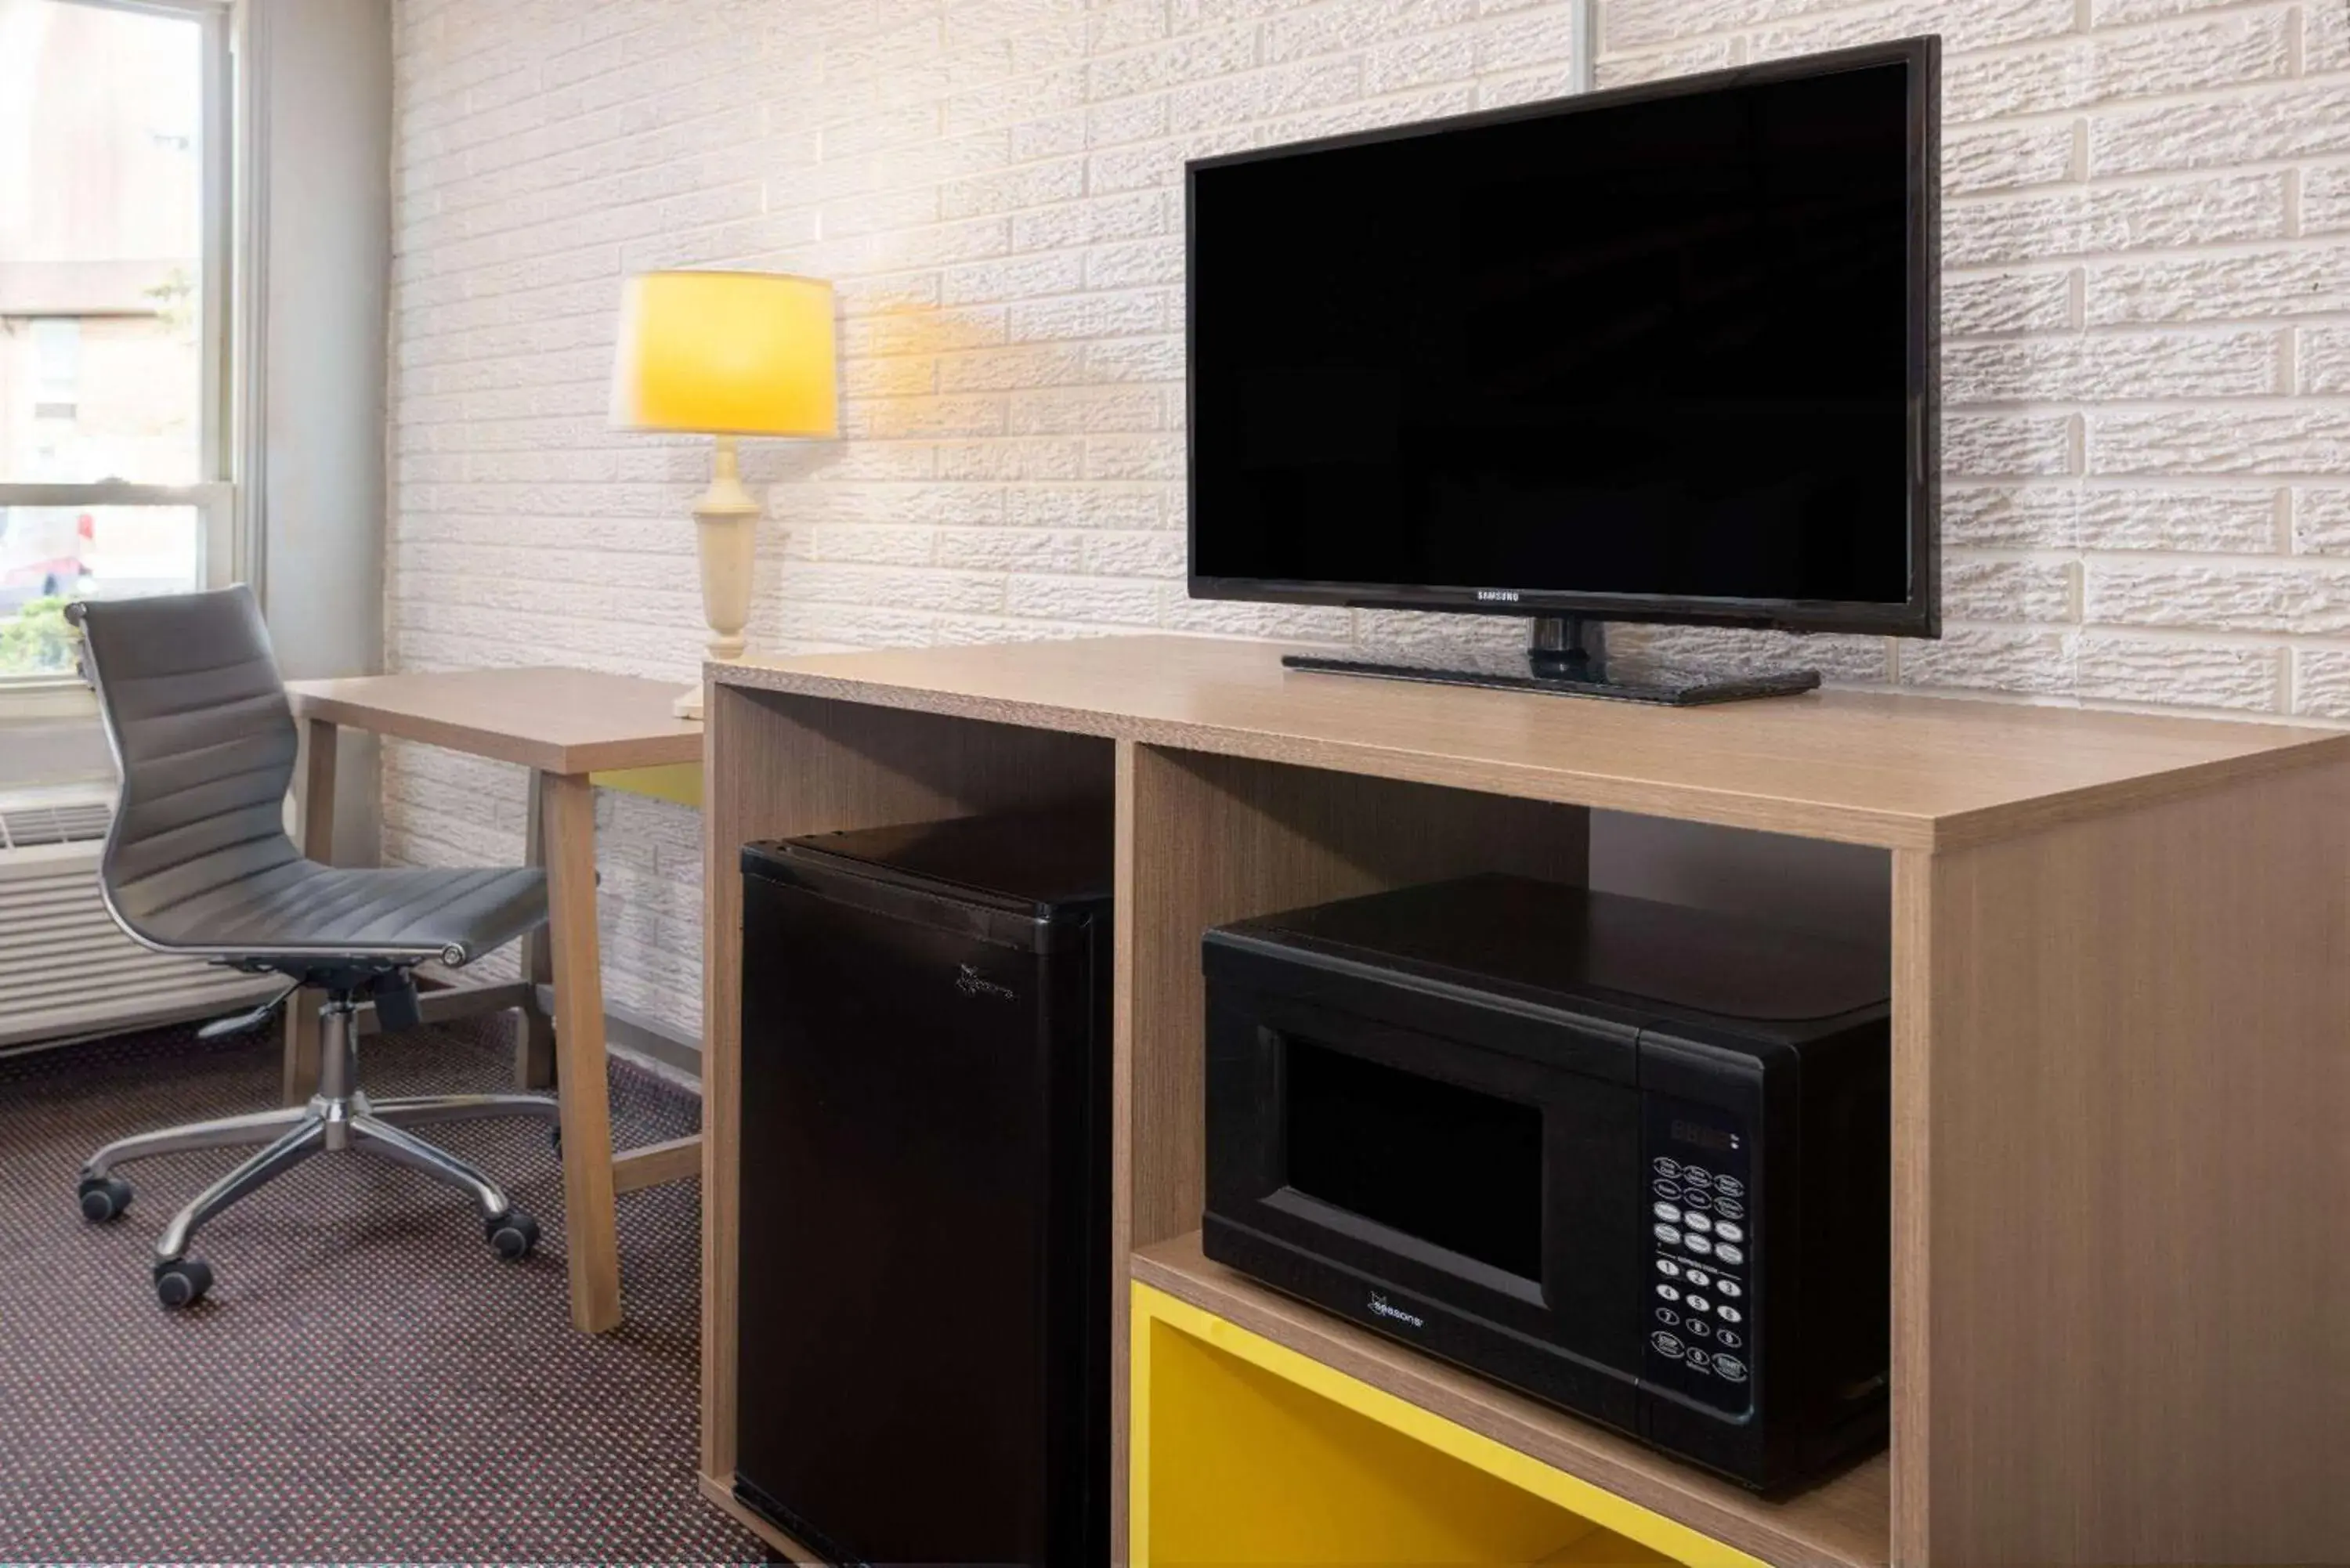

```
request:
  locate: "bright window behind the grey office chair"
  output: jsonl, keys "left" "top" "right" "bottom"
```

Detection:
{"left": 0, "top": 0, "right": 235, "bottom": 691}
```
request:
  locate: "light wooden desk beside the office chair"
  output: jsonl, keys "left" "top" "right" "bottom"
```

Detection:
{"left": 284, "top": 670, "right": 703, "bottom": 1333}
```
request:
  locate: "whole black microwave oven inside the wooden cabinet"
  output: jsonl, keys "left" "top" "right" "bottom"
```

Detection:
{"left": 1201, "top": 877, "right": 1889, "bottom": 1493}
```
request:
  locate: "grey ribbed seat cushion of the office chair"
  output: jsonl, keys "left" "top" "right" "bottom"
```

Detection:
{"left": 136, "top": 861, "right": 548, "bottom": 966}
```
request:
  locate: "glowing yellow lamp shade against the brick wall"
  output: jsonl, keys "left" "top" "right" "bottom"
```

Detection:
{"left": 611, "top": 273, "right": 839, "bottom": 435}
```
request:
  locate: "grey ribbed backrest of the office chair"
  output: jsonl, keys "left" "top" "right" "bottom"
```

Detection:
{"left": 66, "top": 585, "right": 301, "bottom": 938}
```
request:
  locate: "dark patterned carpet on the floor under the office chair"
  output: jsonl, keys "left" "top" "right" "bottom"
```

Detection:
{"left": 0, "top": 1023, "right": 764, "bottom": 1563}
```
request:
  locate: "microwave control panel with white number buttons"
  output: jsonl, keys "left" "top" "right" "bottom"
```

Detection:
{"left": 1640, "top": 1096, "right": 1762, "bottom": 1413}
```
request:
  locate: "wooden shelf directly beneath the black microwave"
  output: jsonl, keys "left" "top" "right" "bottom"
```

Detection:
{"left": 1133, "top": 1232, "right": 1892, "bottom": 1568}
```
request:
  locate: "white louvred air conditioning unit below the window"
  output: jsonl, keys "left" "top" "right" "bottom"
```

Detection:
{"left": 0, "top": 782, "right": 284, "bottom": 1051}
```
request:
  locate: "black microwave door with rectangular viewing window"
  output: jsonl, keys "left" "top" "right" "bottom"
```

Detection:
{"left": 1208, "top": 995, "right": 1645, "bottom": 1387}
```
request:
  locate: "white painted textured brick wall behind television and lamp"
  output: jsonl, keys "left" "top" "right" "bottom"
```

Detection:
{"left": 385, "top": 0, "right": 2350, "bottom": 1032}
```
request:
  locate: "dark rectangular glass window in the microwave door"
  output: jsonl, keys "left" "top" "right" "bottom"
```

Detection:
{"left": 1283, "top": 1037, "right": 1544, "bottom": 1281}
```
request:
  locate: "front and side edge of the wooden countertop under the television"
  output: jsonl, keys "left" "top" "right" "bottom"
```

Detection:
{"left": 707, "top": 665, "right": 2350, "bottom": 851}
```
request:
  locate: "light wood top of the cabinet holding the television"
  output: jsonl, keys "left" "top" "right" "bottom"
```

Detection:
{"left": 710, "top": 637, "right": 2350, "bottom": 849}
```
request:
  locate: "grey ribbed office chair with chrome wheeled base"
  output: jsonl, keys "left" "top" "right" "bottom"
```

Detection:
{"left": 66, "top": 587, "right": 557, "bottom": 1307}
